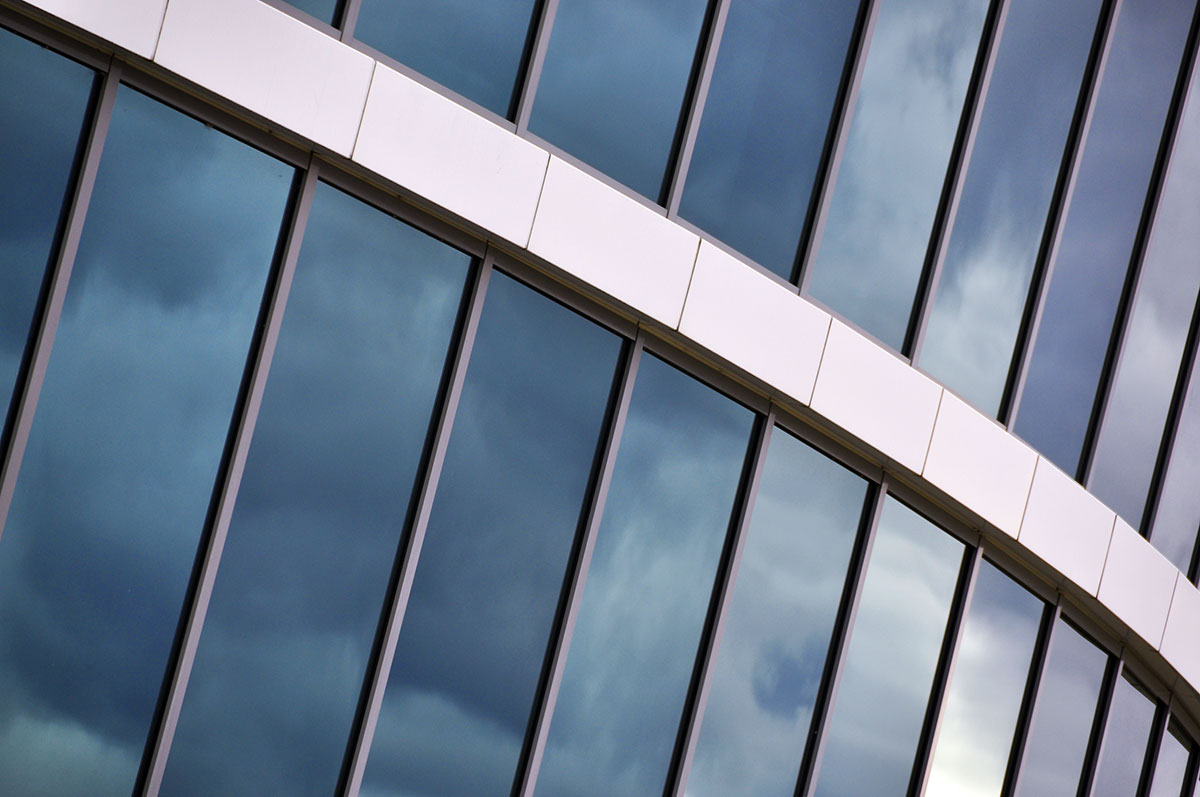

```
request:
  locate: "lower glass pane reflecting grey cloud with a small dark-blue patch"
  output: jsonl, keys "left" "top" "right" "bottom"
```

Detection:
{"left": 688, "top": 429, "right": 866, "bottom": 797}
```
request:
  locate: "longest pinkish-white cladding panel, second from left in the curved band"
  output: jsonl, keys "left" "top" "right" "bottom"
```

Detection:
{"left": 155, "top": 0, "right": 374, "bottom": 155}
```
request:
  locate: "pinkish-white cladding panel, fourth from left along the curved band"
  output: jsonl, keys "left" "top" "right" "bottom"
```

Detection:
{"left": 529, "top": 157, "right": 700, "bottom": 329}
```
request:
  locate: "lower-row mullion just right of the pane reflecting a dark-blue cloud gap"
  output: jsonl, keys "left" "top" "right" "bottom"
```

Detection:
{"left": 794, "top": 474, "right": 888, "bottom": 797}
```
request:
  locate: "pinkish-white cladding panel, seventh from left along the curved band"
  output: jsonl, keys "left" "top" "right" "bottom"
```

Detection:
{"left": 923, "top": 392, "right": 1038, "bottom": 537}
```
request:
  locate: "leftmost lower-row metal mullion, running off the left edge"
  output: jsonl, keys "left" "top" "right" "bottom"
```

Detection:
{"left": 0, "top": 59, "right": 121, "bottom": 542}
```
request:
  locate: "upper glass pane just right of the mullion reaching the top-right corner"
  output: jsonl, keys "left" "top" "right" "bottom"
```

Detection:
{"left": 1087, "top": 45, "right": 1200, "bottom": 527}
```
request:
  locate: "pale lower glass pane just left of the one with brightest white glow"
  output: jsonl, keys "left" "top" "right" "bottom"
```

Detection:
{"left": 815, "top": 497, "right": 962, "bottom": 796}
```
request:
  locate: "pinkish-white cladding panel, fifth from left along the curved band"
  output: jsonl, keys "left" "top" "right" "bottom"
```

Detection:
{"left": 679, "top": 241, "right": 829, "bottom": 405}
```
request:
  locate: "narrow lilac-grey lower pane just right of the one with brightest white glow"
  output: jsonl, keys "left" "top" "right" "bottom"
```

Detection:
{"left": 1018, "top": 618, "right": 1109, "bottom": 797}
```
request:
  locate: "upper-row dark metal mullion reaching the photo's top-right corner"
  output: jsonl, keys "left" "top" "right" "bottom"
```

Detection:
{"left": 1075, "top": 5, "right": 1200, "bottom": 485}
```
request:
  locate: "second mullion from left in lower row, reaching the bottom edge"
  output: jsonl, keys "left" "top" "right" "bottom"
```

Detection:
{"left": 134, "top": 160, "right": 319, "bottom": 795}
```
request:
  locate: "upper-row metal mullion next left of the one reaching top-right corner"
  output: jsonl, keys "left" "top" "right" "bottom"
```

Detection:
{"left": 997, "top": 0, "right": 1122, "bottom": 427}
